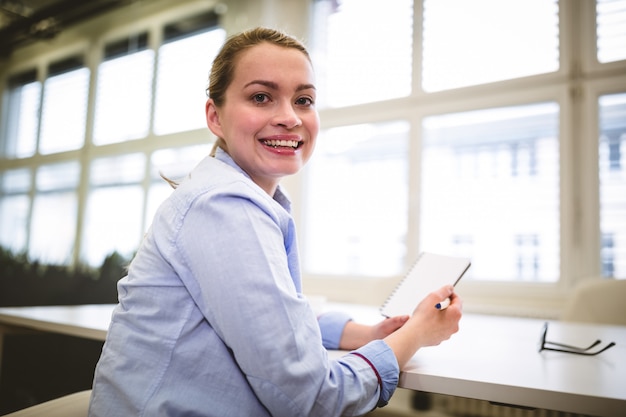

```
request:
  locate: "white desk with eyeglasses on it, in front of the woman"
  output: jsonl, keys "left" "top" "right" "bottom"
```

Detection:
{"left": 0, "top": 304, "right": 626, "bottom": 417}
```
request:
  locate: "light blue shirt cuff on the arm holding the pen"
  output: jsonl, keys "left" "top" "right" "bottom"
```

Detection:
{"left": 351, "top": 340, "right": 400, "bottom": 407}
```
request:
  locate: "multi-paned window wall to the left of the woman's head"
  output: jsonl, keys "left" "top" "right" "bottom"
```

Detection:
{"left": 0, "top": 7, "right": 225, "bottom": 266}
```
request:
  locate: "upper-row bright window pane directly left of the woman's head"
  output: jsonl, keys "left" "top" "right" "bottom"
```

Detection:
{"left": 154, "top": 29, "right": 226, "bottom": 135}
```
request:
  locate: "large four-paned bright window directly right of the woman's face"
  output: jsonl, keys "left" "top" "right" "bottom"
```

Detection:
{"left": 303, "top": 0, "right": 572, "bottom": 283}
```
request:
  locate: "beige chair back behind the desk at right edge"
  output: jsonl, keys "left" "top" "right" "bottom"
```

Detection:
{"left": 561, "top": 279, "right": 626, "bottom": 325}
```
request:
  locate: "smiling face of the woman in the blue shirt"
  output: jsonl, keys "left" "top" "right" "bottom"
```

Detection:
{"left": 206, "top": 43, "right": 319, "bottom": 195}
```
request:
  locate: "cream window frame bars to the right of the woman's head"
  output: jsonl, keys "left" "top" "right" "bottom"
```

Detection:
{"left": 298, "top": 0, "right": 626, "bottom": 318}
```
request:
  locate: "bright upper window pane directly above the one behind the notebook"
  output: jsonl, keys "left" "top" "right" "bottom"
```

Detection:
{"left": 422, "top": 0, "right": 559, "bottom": 92}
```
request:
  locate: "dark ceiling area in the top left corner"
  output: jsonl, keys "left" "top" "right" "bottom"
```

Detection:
{"left": 0, "top": 0, "right": 132, "bottom": 57}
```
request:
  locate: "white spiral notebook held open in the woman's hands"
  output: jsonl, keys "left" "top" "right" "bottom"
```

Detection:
{"left": 380, "top": 252, "right": 471, "bottom": 317}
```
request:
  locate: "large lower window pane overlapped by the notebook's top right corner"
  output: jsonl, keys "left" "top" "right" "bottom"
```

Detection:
{"left": 420, "top": 103, "right": 560, "bottom": 282}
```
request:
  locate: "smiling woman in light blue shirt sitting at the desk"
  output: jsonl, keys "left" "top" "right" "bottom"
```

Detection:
{"left": 90, "top": 28, "right": 461, "bottom": 417}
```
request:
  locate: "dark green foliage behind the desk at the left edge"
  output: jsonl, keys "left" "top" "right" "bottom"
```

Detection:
{"left": 0, "top": 248, "right": 128, "bottom": 307}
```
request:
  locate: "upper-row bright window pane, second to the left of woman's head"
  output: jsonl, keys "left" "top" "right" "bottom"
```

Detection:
{"left": 93, "top": 49, "right": 154, "bottom": 145}
